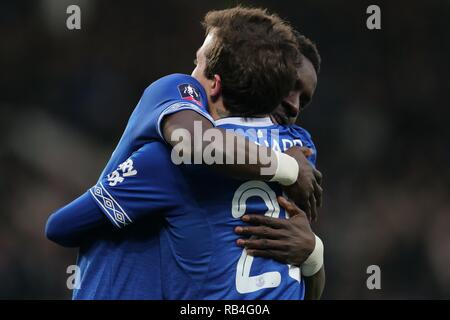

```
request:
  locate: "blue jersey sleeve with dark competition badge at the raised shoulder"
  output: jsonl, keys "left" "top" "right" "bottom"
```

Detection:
{"left": 129, "top": 74, "right": 214, "bottom": 141}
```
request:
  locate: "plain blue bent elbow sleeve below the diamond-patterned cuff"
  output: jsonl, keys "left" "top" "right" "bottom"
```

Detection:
{"left": 45, "top": 191, "right": 108, "bottom": 247}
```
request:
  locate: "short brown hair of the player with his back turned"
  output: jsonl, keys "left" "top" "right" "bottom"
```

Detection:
{"left": 203, "top": 6, "right": 301, "bottom": 116}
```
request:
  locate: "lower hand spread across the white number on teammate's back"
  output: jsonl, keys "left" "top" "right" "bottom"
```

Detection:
{"left": 235, "top": 197, "right": 315, "bottom": 266}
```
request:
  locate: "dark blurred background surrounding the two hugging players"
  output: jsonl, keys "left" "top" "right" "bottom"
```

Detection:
{"left": 0, "top": 0, "right": 450, "bottom": 299}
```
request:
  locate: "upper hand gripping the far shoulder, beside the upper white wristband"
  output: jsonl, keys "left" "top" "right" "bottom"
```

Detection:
{"left": 283, "top": 147, "right": 323, "bottom": 221}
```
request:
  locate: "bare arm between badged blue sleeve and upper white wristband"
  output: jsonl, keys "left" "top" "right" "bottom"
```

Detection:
{"left": 162, "top": 111, "right": 278, "bottom": 181}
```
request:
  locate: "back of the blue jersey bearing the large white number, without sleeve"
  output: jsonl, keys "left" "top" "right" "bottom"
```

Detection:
{"left": 160, "top": 118, "right": 316, "bottom": 300}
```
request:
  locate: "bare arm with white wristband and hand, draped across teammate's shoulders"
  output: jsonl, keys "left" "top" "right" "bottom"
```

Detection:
{"left": 161, "top": 110, "right": 322, "bottom": 219}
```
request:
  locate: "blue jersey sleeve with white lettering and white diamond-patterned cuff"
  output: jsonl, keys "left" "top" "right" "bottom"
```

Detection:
{"left": 89, "top": 142, "right": 190, "bottom": 228}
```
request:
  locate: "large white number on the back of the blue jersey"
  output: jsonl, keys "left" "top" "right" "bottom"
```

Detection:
{"left": 231, "top": 181, "right": 300, "bottom": 294}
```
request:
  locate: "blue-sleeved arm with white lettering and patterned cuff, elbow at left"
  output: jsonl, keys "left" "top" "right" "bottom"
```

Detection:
{"left": 46, "top": 142, "right": 204, "bottom": 247}
